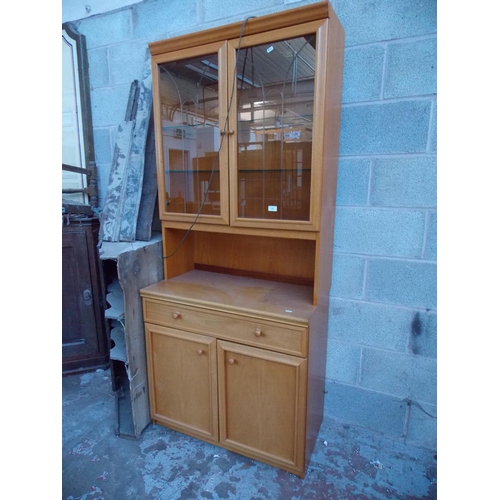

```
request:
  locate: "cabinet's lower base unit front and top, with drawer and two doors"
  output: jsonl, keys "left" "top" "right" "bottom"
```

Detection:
{"left": 141, "top": 270, "right": 316, "bottom": 475}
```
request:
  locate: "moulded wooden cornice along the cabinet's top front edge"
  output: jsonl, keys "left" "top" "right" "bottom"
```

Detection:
{"left": 149, "top": 0, "right": 333, "bottom": 56}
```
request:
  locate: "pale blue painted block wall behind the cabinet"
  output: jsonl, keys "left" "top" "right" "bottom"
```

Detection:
{"left": 75, "top": 0, "right": 437, "bottom": 448}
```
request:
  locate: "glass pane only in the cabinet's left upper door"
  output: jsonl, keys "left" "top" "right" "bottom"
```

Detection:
{"left": 159, "top": 53, "right": 221, "bottom": 216}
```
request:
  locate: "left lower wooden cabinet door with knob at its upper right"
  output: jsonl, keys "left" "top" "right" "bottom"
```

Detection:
{"left": 145, "top": 323, "right": 219, "bottom": 442}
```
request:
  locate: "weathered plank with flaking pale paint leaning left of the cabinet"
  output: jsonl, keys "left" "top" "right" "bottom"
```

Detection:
{"left": 100, "top": 51, "right": 152, "bottom": 241}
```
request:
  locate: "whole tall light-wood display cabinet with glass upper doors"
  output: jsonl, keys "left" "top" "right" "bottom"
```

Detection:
{"left": 141, "top": 2, "right": 344, "bottom": 476}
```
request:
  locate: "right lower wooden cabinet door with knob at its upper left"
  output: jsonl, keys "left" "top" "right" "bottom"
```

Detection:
{"left": 217, "top": 341, "right": 307, "bottom": 476}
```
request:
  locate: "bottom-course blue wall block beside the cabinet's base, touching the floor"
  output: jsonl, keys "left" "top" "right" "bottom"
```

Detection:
{"left": 324, "top": 379, "right": 406, "bottom": 438}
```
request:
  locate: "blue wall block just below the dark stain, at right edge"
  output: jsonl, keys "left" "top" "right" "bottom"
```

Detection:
{"left": 360, "top": 347, "right": 437, "bottom": 404}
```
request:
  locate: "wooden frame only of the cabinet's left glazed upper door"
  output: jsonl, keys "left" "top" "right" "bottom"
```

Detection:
{"left": 151, "top": 40, "right": 229, "bottom": 224}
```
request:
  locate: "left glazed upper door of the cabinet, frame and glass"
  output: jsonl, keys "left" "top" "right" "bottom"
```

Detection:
{"left": 155, "top": 44, "right": 229, "bottom": 224}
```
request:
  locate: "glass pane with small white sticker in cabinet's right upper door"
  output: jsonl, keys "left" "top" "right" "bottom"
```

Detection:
{"left": 237, "top": 34, "right": 316, "bottom": 221}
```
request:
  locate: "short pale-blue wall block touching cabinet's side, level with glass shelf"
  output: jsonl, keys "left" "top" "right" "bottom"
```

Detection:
{"left": 336, "top": 158, "right": 370, "bottom": 205}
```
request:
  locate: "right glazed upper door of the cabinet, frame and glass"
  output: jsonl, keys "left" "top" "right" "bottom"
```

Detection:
{"left": 228, "top": 22, "right": 322, "bottom": 230}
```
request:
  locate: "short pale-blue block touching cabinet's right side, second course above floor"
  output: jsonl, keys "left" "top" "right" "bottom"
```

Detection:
{"left": 326, "top": 338, "right": 361, "bottom": 385}
